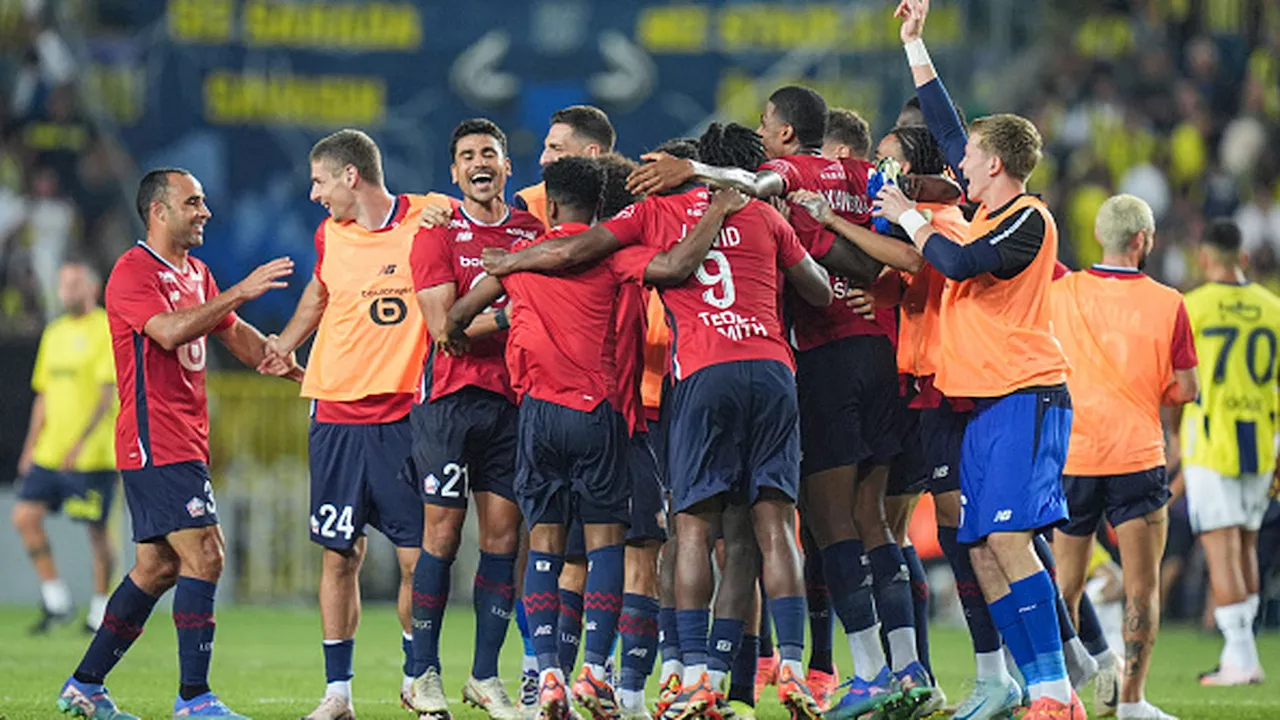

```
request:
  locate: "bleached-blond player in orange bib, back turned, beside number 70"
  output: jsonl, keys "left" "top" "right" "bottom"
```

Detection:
{"left": 1052, "top": 195, "right": 1199, "bottom": 720}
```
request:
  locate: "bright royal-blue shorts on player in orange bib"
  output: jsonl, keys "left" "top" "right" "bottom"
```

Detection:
{"left": 957, "top": 386, "right": 1071, "bottom": 544}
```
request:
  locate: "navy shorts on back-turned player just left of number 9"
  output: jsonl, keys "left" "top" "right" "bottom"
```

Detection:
{"left": 516, "top": 396, "right": 631, "bottom": 528}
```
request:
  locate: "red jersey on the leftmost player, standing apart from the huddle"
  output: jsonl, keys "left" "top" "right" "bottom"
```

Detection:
{"left": 106, "top": 242, "right": 236, "bottom": 470}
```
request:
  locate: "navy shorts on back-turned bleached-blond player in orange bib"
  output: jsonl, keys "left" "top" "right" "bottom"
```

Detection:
{"left": 1060, "top": 465, "right": 1170, "bottom": 537}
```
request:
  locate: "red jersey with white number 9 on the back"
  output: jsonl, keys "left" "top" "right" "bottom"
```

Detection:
{"left": 605, "top": 188, "right": 806, "bottom": 379}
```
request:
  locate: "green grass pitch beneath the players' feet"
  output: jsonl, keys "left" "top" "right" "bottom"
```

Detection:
{"left": 0, "top": 606, "right": 1280, "bottom": 720}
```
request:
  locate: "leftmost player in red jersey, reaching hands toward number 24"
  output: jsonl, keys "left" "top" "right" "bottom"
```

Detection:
{"left": 58, "top": 168, "right": 295, "bottom": 720}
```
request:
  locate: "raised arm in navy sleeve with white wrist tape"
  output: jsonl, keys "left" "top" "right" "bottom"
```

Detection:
{"left": 893, "top": 0, "right": 969, "bottom": 179}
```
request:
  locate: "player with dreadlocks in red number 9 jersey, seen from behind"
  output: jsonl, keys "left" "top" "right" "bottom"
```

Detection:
{"left": 486, "top": 122, "right": 832, "bottom": 717}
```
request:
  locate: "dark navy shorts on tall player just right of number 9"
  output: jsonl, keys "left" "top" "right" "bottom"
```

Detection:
{"left": 796, "top": 336, "right": 901, "bottom": 478}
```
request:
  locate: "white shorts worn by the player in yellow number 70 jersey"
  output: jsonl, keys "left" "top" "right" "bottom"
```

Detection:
{"left": 1183, "top": 465, "right": 1271, "bottom": 534}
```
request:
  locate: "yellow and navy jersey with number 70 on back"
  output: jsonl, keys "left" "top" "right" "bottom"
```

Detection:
{"left": 1183, "top": 283, "right": 1280, "bottom": 478}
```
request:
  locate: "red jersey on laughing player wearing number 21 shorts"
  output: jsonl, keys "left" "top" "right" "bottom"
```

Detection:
{"left": 410, "top": 205, "right": 545, "bottom": 402}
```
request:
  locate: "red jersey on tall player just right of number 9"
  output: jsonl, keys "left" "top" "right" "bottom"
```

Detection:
{"left": 760, "top": 155, "right": 895, "bottom": 350}
